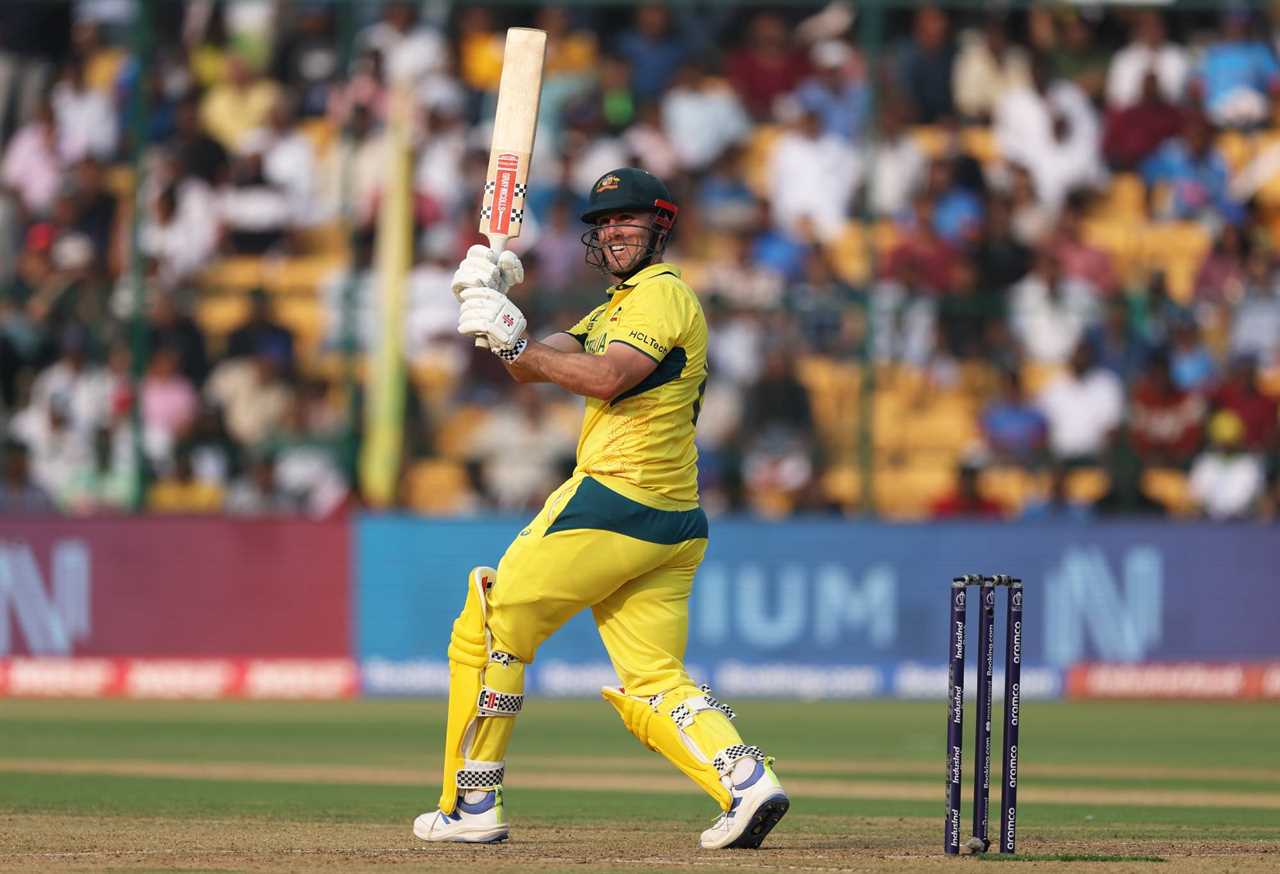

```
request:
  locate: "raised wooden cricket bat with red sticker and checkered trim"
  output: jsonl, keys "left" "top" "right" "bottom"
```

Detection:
{"left": 476, "top": 27, "right": 547, "bottom": 348}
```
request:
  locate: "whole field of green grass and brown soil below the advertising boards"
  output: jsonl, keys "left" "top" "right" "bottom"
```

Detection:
{"left": 0, "top": 699, "right": 1280, "bottom": 873}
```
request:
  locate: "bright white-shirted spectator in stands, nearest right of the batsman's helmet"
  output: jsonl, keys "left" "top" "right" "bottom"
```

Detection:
{"left": 769, "top": 104, "right": 861, "bottom": 239}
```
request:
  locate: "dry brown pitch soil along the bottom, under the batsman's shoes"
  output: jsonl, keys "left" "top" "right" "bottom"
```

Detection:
{"left": 0, "top": 814, "right": 1280, "bottom": 874}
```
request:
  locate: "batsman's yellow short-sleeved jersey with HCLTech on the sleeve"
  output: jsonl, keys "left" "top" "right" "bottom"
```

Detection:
{"left": 568, "top": 264, "right": 707, "bottom": 509}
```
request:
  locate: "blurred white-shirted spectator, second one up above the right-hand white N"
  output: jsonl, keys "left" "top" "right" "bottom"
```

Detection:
{"left": 1009, "top": 251, "right": 1098, "bottom": 365}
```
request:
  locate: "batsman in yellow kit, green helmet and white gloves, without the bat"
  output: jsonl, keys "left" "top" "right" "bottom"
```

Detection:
{"left": 413, "top": 168, "right": 790, "bottom": 850}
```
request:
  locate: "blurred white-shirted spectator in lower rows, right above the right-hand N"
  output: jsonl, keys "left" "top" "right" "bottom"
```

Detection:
{"left": 1036, "top": 343, "right": 1124, "bottom": 463}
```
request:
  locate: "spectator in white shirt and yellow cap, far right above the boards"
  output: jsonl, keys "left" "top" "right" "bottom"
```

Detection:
{"left": 1190, "top": 409, "right": 1266, "bottom": 520}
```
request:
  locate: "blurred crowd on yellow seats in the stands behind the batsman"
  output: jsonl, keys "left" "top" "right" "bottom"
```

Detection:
{"left": 0, "top": 0, "right": 1280, "bottom": 520}
